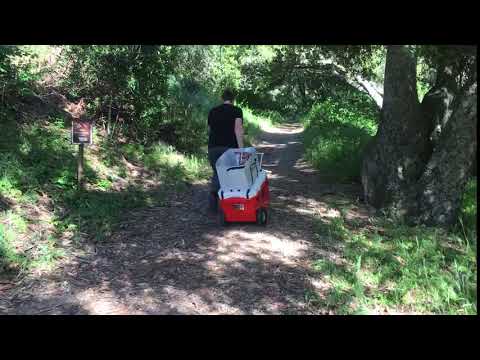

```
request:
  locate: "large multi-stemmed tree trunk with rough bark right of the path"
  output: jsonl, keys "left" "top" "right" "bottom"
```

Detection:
{"left": 362, "top": 46, "right": 477, "bottom": 226}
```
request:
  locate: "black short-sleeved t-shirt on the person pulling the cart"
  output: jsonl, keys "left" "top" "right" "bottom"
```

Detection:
{"left": 208, "top": 104, "right": 243, "bottom": 148}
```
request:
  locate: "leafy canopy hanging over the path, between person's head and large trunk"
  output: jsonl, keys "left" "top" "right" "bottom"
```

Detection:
{"left": 241, "top": 45, "right": 385, "bottom": 116}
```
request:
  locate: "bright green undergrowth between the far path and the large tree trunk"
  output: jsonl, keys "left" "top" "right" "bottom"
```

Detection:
{"left": 303, "top": 91, "right": 378, "bottom": 181}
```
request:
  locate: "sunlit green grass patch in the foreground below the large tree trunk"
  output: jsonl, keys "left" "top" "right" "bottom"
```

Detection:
{"left": 308, "top": 188, "right": 477, "bottom": 314}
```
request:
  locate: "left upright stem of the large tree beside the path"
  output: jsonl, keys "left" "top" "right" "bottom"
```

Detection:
{"left": 362, "top": 46, "right": 432, "bottom": 216}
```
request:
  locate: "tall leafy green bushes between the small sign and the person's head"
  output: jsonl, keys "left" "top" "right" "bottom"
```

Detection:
{"left": 58, "top": 45, "right": 253, "bottom": 152}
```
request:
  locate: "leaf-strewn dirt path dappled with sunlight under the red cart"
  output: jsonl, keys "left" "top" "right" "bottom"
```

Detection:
{"left": 0, "top": 124, "right": 368, "bottom": 314}
